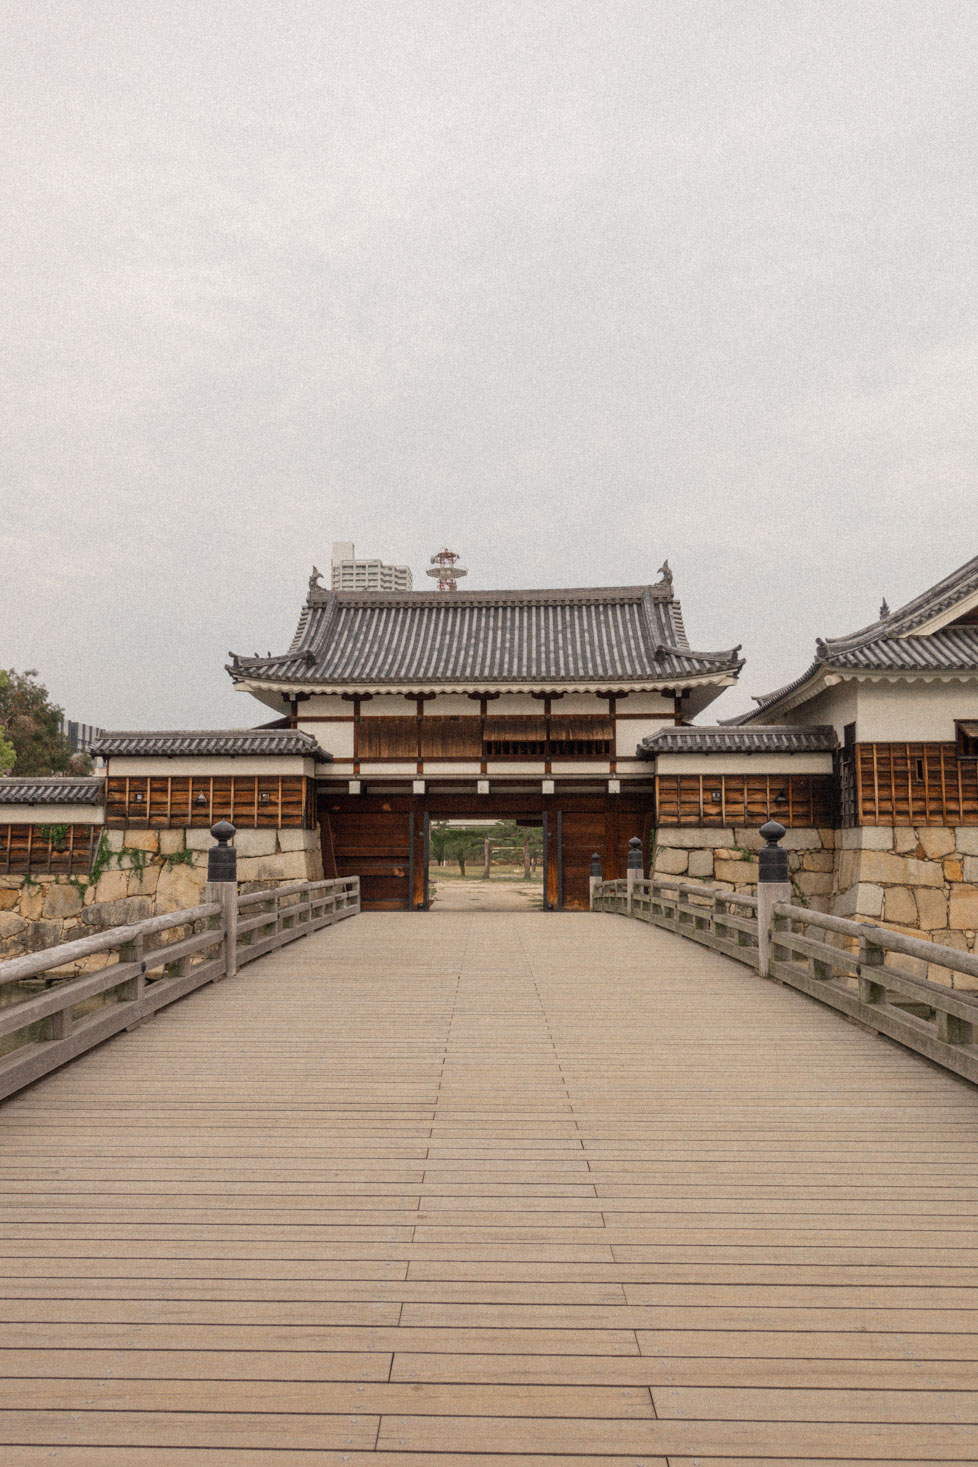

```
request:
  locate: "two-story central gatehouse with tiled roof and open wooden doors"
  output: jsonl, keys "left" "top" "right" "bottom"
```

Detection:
{"left": 227, "top": 566, "right": 742, "bottom": 908}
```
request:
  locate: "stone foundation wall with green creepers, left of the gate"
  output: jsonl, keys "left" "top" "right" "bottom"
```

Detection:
{"left": 0, "top": 830, "right": 323, "bottom": 962}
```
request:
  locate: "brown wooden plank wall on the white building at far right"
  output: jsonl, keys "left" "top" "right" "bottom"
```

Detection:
{"left": 855, "top": 742, "right": 978, "bottom": 826}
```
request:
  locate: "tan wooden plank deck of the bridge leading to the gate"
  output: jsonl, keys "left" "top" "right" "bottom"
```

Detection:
{"left": 0, "top": 912, "right": 978, "bottom": 1467}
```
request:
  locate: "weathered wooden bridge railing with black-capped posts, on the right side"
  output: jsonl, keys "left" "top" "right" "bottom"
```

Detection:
{"left": 591, "top": 822, "right": 978, "bottom": 1083}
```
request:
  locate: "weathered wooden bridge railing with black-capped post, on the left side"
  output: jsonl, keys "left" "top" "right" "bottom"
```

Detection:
{"left": 0, "top": 830, "right": 359, "bottom": 1099}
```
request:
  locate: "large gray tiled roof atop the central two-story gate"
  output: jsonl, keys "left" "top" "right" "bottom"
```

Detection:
{"left": 229, "top": 582, "right": 743, "bottom": 687}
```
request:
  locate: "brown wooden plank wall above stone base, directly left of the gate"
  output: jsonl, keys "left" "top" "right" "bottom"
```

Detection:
{"left": 106, "top": 775, "right": 315, "bottom": 830}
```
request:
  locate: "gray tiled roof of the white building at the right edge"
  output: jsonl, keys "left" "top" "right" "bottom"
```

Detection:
{"left": 738, "top": 556, "right": 978, "bottom": 725}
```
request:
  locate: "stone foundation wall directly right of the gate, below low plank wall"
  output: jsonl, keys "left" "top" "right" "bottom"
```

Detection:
{"left": 652, "top": 826, "right": 836, "bottom": 911}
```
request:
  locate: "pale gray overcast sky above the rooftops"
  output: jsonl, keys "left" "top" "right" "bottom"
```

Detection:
{"left": 0, "top": 0, "right": 978, "bottom": 728}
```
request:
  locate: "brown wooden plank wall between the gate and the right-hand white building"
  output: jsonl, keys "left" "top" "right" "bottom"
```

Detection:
{"left": 655, "top": 775, "right": 837, "bottom": 827}
